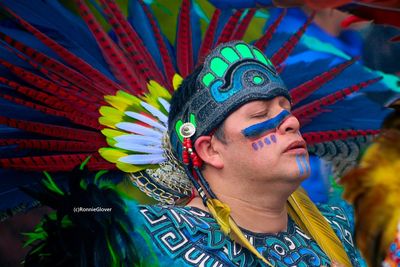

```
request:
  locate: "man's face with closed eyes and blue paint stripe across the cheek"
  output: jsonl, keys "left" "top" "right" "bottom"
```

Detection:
{"left": 216, "top": 96, "right": 310, "bottom": 182}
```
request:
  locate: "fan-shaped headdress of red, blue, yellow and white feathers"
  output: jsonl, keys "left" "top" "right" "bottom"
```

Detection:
{"left": 0, "top": 0, "right": 396, "bottom": 266}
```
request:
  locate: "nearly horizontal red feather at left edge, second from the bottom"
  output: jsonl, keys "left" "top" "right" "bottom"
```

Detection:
{"left": 0, "top": 139, "right": 103, "bottom": 152}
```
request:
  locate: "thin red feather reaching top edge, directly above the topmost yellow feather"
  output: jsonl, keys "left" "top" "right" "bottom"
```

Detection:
{"left": 139, "top": 0, "right": 176, "bottom": 92}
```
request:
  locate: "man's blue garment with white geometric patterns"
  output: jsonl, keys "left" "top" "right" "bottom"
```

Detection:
{"left": 134, "top": 205, "right": 364, "bottom": 267}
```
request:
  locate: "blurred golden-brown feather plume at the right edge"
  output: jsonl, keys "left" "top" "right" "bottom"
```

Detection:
{"left": 341, "top": 130, "right": 400, "bottom": 266}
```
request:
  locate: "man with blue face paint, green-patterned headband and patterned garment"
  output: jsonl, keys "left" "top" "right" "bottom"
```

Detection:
{"left": 134, "top": 42, "right": 360, "bottom": 266}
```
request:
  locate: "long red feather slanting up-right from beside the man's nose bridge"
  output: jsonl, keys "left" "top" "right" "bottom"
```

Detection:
{"left": 293, "top": 77, "right": 382, "bottom": 125}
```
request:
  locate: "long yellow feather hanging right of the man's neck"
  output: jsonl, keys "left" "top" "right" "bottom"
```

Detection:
{"left": 288, "top": 188, "right": 352, "bottom": 266}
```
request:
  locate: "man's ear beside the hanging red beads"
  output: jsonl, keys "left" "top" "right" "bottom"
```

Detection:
{"left": 194, "top": 136, "right": 224, "bottom": 169}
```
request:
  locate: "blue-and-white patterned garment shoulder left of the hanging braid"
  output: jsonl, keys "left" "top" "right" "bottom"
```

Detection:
{"left": 139, "top": 205, "right": 254, "bottom": 266}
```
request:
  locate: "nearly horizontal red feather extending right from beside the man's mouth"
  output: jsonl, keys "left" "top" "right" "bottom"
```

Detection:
{"left": 303, "top": 130, "right": 380, "bottom": 145}
